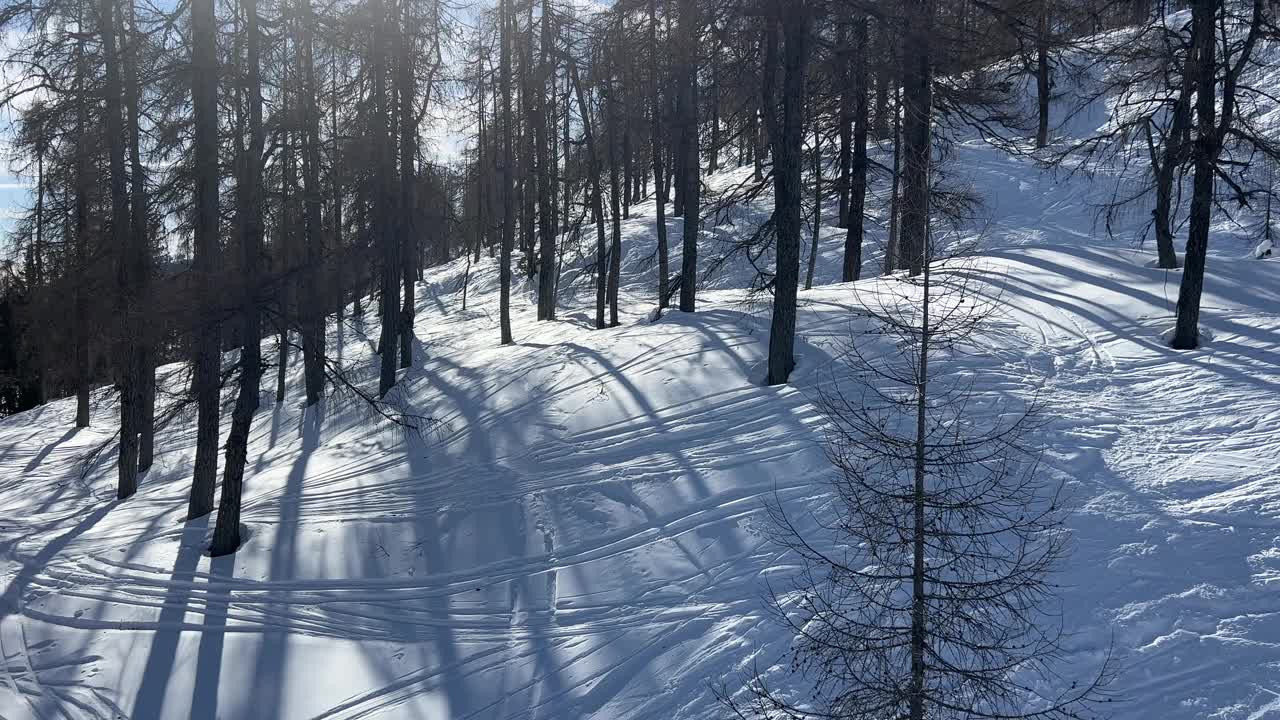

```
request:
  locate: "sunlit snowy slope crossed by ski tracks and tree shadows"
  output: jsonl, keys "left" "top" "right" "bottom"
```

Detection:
{"left": 0, "top": 96, "right": 1280, "bottom": 720}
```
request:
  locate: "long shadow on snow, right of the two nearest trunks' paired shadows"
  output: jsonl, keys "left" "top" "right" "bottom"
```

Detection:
{"left": 247, "top": 401, "right": 324, "bottom": 717}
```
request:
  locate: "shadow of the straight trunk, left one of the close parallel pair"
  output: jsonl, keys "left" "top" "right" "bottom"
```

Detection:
{"left": 132, "top": 515, "right": 209, "bottom": 720}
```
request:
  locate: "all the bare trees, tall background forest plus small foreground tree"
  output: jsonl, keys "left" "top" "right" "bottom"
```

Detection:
{"left": 0, "top": 0, "right": 1280, "bottom": 707}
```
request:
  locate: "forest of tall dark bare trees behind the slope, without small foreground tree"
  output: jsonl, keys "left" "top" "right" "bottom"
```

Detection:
{"left": 3, "top": 0, "right": 1275, "bottom": 548}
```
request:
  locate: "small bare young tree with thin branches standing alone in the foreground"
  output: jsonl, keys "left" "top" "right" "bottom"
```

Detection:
{"left": 721, "top": 248, "right": 1110, "bottom": 720}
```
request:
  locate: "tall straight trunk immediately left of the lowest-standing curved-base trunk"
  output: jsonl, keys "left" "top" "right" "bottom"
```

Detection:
{"left": 187, "top": 0, "right": 221, "bottom": 518}
